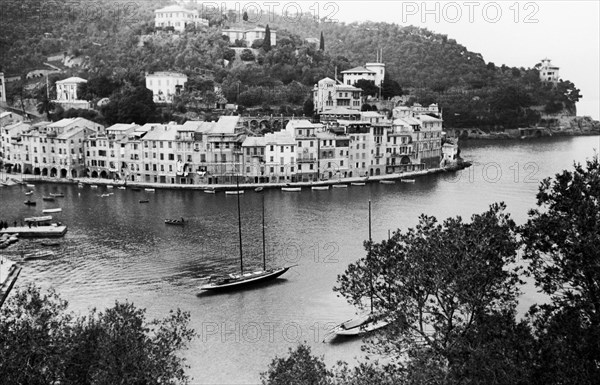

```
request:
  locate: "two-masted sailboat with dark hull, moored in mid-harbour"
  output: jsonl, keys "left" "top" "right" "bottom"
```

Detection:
{"left": 200, "top": 180, "right": 293, "bottom": 291}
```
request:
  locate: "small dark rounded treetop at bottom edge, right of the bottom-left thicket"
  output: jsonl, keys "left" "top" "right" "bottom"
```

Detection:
{"left": 260, "top": 344, "right": 331, "bottom": 385}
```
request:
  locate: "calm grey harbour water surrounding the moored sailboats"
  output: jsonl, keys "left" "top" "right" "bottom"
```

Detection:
{"left": 0, "top": 136, "right": 600, "bottom": 384}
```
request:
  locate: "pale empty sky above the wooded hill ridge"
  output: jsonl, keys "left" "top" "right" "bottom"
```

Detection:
{"left": 221, "top": 0, "right": 600, "bottom": 120}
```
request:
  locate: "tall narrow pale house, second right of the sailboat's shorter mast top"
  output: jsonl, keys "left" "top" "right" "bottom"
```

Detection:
{"left": 285, "top": 119, "right": 324, "bottom": 182}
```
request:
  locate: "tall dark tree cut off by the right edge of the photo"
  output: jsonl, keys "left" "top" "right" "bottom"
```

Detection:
{"left": 521, "top": 154, "right": 600, "bottom": 384}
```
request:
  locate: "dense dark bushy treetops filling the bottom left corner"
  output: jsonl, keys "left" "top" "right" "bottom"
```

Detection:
{"left": 0, "top": 285, "right": 195, "bottom": 385}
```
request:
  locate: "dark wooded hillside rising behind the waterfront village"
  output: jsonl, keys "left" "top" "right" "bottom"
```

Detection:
{"left": 0, "top": 0, "right": 581, "bottom": 129}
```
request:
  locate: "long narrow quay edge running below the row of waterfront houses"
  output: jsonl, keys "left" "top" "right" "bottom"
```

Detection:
{"left": 6, "top": 161, "right": 471, "bottom": 192}
